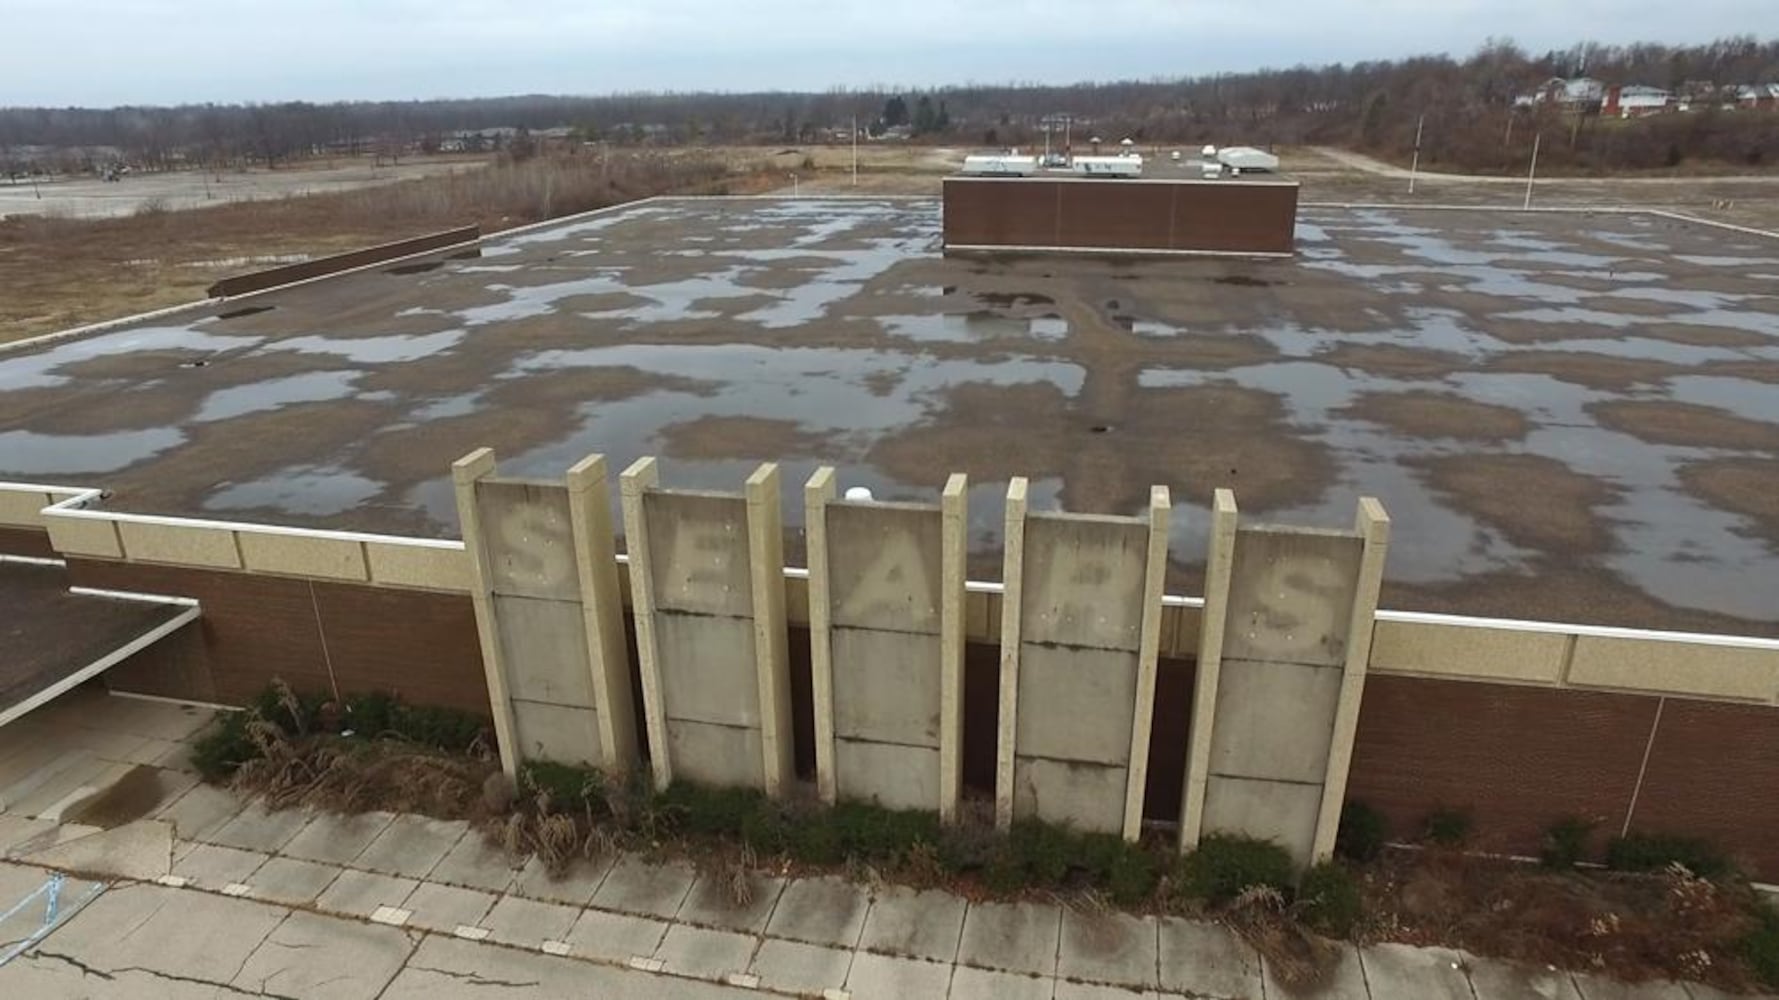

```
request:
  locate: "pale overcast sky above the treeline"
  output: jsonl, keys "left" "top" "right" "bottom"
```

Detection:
{"left": 0, "top": 0, "right": 1779, "bottom": 107}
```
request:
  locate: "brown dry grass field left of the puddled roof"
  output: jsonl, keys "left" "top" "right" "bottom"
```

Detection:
{"left": 0, "top": 151, "right": 767, "bottom": 342}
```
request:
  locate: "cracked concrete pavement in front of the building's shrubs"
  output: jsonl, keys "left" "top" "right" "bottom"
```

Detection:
{"left": 0, "top": 703, "right": 1771, "bottom": 1000}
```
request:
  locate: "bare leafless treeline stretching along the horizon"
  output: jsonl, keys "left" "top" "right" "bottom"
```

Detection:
{"left": 0, "top": 37, "right": 1779, "bottom": 171}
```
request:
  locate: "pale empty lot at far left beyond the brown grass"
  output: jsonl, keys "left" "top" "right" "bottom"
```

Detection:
{"left": 0, "top": 157, "right": 489, "bottom": 219}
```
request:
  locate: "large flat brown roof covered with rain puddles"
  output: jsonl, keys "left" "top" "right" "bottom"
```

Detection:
{"left": 0, "top": 198, "right": 1779, "bottom": 633}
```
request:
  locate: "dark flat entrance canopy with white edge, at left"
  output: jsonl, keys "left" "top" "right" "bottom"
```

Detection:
{"left": 0, "top": 557, "right": 197, "bottom": 726}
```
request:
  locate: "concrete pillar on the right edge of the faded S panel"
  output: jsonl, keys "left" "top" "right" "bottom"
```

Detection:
{"left": 568, "top": 456, "right": 637, "bottom": 778}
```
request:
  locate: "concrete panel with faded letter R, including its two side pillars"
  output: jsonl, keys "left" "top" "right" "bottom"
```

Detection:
{"left": 996, "top": 480, "right": 1169, "bottom": 838}
